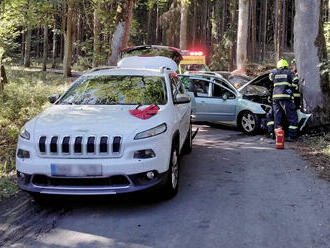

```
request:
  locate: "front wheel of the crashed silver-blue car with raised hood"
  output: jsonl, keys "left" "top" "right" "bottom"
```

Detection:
{"left": 238, "top": 111, "right": 260, "bottom": 135}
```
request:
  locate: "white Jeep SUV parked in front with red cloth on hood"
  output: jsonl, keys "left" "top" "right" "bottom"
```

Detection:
{"left": 16, "top": 57, "right": 192, "bottom": 197}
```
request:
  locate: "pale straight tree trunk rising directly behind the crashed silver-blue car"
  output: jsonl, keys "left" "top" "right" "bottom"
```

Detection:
{"left": 236, "top": 0, "right": 249, "bottom": 73}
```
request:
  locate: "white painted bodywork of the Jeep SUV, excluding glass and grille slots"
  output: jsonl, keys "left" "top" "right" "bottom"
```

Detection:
{"left": 16, "top": 58, "right": 191, "bottom": 195}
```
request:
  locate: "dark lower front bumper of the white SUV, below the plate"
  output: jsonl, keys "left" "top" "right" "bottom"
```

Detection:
{"left": 17, "top": 171, "right": 168, "bottom": 195}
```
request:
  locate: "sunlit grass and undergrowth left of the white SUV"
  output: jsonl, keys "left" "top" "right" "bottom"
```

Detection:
{"left": 0, "top": 66, "right": 75, "bottom": 190}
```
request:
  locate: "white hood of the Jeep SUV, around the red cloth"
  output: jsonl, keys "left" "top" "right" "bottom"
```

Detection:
{"left": 34, "top": 105, "right": 164, "bottom": 136}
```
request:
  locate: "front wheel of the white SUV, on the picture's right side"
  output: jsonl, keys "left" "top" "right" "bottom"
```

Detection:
{"left": 163, "top": 143, "right": 180, "bottom": 199}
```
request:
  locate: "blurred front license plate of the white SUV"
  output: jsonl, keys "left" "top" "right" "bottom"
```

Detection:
{"left": 50, "top": 164, "right": 102, "bottom": 177}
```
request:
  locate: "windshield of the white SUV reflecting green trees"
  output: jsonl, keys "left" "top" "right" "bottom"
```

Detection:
{"left": 57, "top": 75, "right": 167, "bottom": 105}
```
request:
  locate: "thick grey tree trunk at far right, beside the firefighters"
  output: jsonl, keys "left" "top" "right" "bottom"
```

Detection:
{"left": 294, "top": 0, "right": 330, "bottom": 125}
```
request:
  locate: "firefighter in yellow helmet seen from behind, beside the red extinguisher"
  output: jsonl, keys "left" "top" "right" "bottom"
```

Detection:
{"left": 269, "top": 59, "right": 298, "bottom": 142}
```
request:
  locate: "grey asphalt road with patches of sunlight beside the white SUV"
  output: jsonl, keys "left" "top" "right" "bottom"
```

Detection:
{"left": 2, "top": 126, "right": 330, "bottom": 248}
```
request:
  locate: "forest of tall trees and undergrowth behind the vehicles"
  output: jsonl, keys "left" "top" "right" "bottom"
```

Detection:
{"left": 0, "top": 0, "right": 330, "bottom": 174}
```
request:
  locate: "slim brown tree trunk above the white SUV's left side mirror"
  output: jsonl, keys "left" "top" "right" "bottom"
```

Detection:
{"left": 63, "top": 1, "right": 74, "bottom": 77}
